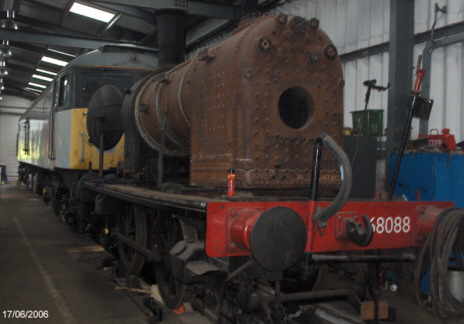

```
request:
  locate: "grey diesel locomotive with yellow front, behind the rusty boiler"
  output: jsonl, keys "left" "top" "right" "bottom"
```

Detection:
{"left": 17, "top": 46, "right": 157, "bottom": 218}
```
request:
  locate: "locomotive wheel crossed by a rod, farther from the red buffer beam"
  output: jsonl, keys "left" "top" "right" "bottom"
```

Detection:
{"left": 117, "top": 204, "right": 147, "bottom": 275}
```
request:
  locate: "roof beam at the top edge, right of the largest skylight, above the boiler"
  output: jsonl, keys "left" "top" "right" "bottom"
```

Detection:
{"left": 89, "top": 0, "right": 248, "bottom": 20}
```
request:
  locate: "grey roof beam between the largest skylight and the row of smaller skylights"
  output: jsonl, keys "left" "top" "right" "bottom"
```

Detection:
{"left": 0, "top": 29, "right": 139, "bottom": 49}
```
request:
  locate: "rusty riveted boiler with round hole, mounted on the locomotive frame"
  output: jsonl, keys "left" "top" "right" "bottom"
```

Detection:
{"left": 125, "top": 15, "right": 343, "bottom": 188}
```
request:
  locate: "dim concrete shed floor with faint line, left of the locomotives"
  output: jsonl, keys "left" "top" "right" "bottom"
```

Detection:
{"left": 0, "top": 180, "right": 207, "bottom": 324}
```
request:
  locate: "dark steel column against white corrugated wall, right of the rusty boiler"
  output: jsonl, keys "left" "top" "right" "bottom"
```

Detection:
{"left": 385, "top": 0, "right": 414, "bottom": 191}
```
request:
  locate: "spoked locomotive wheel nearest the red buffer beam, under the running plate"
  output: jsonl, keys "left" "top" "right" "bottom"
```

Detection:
{"left": 153, "top": 215, "right": 188, "bottom": 309}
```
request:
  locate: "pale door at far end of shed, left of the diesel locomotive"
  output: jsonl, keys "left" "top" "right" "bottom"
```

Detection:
{"left": 0, "top": 114, "right": 20, "bottom": 176}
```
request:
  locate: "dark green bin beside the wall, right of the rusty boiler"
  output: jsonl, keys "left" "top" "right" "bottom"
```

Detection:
{"left": 351, "top": 109, "right": 383, "bottom": 136}
